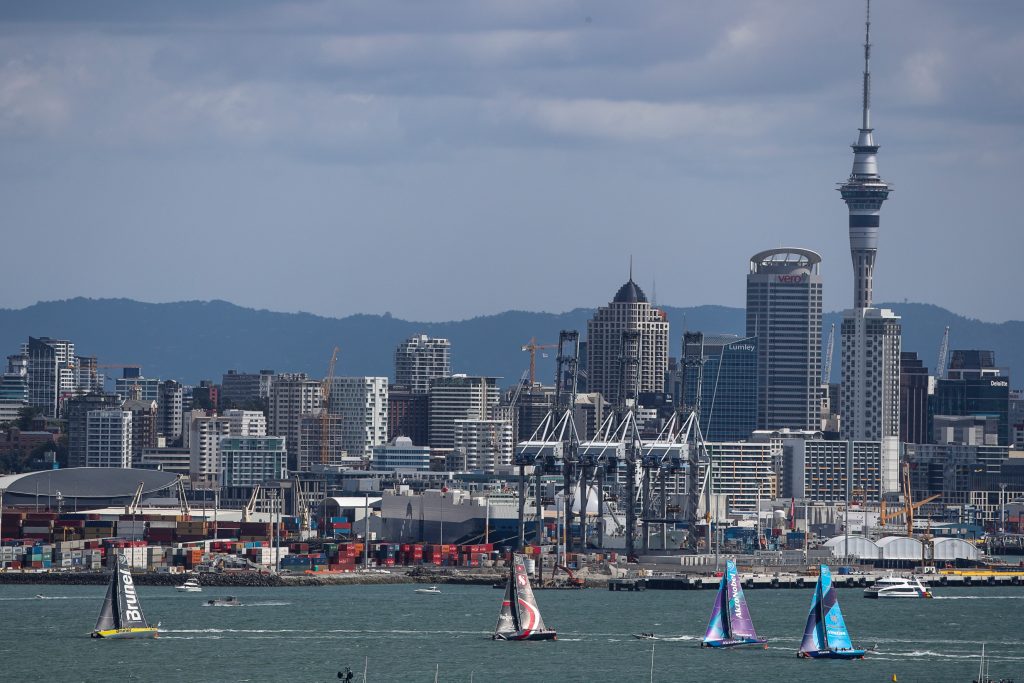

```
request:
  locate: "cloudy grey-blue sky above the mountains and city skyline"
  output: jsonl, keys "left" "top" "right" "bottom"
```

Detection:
{"left": 0, "top": 0, "right": 1024, "bottom": 322}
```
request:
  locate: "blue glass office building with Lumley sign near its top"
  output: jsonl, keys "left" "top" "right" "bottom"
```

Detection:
{"left": 682, "top": 332, "right": 758, "bottom": 441}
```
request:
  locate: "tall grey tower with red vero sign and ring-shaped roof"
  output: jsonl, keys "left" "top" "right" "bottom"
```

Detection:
{"left": 745, "top": 248, "right": 822, "bottom": 429}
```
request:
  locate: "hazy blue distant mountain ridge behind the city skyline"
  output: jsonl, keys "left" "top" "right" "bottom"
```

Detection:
{"left": 0, "top": 298, "right": 1024, "bottom": 386}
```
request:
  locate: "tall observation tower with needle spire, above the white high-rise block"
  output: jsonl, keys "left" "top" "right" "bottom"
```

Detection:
{"left": 839, "top": 0, "right": 892, "bottom": 308}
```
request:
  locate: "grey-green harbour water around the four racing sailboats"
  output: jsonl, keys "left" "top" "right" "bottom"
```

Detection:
{"left": 0, "top": 585, "right": 1024, "bottom": 683}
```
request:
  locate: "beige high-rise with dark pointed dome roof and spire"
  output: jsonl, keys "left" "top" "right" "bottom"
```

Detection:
{"left": 586, "top": 272, "right": 669, "bottom": 404}
